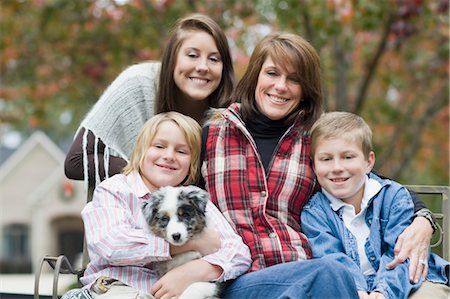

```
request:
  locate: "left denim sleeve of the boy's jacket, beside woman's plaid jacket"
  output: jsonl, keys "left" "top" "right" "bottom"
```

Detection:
{"left": 301, "top": 197, "right": 368, "bottom": 291}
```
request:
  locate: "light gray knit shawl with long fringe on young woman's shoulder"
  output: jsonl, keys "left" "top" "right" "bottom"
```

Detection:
{"left": 75, "top": 61, "right": 161, "bottom": 186}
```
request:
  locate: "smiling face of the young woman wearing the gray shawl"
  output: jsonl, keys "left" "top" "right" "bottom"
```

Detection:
{"left": 173, "top": 31, "right": 223, "bottom": 101}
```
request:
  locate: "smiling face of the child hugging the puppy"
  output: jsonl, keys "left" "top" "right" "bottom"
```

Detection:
{"left": 140, "top": 120, "right": 191, "bottom": 191}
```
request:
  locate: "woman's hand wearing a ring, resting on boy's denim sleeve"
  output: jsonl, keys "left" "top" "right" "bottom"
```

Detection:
{"left": 386, "top": 217, "right": 433, "bottom": 283}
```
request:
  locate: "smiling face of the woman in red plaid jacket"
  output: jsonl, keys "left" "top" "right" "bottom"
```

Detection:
{"left": 255, "top": 57, "right": 302, "bottom": 120}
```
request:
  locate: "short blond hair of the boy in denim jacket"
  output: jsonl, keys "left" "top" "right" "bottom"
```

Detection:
{"left": 311, "top": 111, "right": 372, "bottom": 160}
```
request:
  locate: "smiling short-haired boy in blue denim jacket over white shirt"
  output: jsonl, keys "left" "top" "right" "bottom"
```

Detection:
{"left": 301, "top": 112, "right": 450, "bottom": 299}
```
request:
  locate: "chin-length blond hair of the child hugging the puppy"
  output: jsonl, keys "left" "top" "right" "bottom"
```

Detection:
{"left": 122, "top": 111, "right": 202, "bottom": 185}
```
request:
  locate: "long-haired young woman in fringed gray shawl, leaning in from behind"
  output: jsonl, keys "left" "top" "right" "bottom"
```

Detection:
{"left": 64, "top": 14, "right": 234, "bottom": 186}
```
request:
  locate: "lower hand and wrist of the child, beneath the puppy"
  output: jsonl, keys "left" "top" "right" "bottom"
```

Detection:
{"left": 151, "top": 259, "right": 223, "bottom": 299}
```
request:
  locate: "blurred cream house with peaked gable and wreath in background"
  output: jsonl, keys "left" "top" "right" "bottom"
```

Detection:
{"left": 0, "top": 131, "right": 86, "bottom": 273}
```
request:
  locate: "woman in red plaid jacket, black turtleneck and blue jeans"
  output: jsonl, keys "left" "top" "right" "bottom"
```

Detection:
{"left": 202, "top": 33, "right": 438, "bottom": 298}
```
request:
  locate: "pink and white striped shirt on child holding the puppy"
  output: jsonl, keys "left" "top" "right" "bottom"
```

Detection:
{"left": 81, "top": 173, "right": 251, "bottom": 293}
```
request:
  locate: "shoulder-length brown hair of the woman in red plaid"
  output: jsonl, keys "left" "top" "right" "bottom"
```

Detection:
{"left": 236, "top": 32, "right": 323, "bottom": 130}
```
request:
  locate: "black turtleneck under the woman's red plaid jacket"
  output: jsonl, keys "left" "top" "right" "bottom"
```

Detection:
{"left": 247, "top": 112, "right": 290, "bottom": 173}
